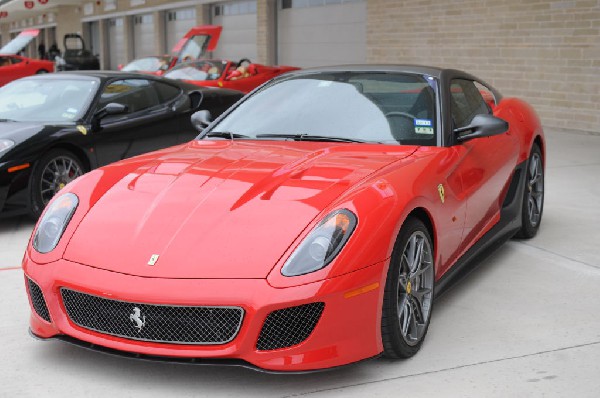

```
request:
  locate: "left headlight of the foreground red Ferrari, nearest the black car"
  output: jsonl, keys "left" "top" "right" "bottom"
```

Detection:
{"left": 33, "top": 193, "right": 79, "bottom": 253}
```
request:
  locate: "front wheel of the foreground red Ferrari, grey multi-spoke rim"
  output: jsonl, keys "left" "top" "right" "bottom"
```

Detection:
{"left": 381, "top": 217, "right": 435, "bottom": 358}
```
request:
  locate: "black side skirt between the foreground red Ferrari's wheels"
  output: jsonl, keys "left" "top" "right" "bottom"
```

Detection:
{"left": 435, "top": 159, "right": 529, "bottom": 298}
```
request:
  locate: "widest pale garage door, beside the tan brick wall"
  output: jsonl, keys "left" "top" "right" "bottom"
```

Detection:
{"left": 277, "top": 0, "right": 367, "bottom": 67}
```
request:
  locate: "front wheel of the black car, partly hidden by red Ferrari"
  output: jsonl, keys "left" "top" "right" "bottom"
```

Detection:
{"left": 29, "top": 149, "right": 86, "bottom": 218}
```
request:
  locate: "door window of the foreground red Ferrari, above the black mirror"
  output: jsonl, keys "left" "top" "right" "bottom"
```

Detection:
{"left": 450, "top": 79, "right": 491, "bottom": 128}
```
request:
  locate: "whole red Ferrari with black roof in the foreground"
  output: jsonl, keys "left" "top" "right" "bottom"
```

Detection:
{"left": 23, "top": 65, "right": 545, "bottom": 371}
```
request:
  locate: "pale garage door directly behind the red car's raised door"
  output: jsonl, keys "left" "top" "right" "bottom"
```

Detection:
{"left": 212, "top": 1, "right": 257, "bottom": 61}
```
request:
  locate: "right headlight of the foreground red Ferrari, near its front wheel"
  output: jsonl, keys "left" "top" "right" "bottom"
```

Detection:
{"left": 281, "top": 209, "right": 356, "bottom": 276}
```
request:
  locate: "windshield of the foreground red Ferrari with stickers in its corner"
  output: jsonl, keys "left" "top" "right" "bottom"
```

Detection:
{"left": 207, "top": 72, "right": 436, "bottom": 145}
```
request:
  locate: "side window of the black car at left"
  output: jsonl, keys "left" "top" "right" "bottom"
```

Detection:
{"left": 98, "top": 79, "right": 159, "bottom": 113}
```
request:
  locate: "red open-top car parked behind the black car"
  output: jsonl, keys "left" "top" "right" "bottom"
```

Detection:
{"left": 164, "top": 59, "right": 300, "bottom": 93}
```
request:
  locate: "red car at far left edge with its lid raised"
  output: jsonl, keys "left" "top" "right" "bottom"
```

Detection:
{"left": 0, "top": 29, "right": 54, "bottom": 86}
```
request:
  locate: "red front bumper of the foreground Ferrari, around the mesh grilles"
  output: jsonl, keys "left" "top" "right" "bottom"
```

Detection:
{"left": 23, "top": 253, "right": 386, "bottom": 371}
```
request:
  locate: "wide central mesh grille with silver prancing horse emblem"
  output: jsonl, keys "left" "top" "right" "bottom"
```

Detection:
{"left": 60, "top": 288, "right": 244, "bottom": 344}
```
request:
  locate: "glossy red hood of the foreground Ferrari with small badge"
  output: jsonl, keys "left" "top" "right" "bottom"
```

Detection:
{"left": 64, "top": 140, "right": 416, "bottom": 278}
